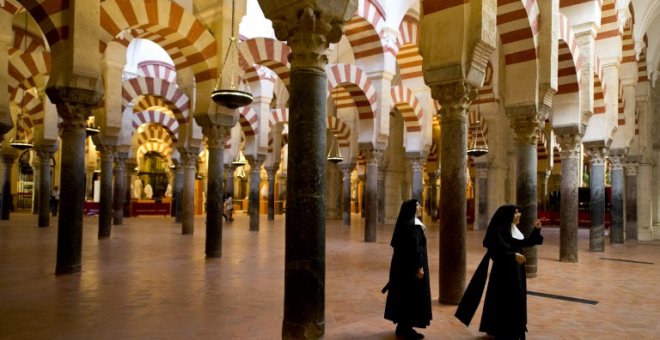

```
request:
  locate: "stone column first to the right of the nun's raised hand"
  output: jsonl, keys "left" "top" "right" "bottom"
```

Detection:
{"left": 557, "top": 134, "right": 582, "bottom": 263}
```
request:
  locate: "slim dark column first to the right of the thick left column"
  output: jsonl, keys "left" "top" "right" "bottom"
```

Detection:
{"left": 97, "top": 145, "right": 115, "bottom": 239}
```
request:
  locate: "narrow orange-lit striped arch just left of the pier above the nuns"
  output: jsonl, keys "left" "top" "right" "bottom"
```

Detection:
{"left": 396, "top": 15, "right": 423, "bottom": 80}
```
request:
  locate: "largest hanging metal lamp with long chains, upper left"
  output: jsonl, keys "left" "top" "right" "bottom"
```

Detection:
{"left": 211, "top": 0, "right": 253, "bottom": 110}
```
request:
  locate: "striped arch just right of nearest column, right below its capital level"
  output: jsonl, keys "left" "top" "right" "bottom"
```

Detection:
{"left": 326, "top": 64, "right": 377, "bottom": 120}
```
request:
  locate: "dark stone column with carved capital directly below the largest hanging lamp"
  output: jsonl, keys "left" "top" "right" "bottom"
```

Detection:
{"left": 202, "top": 125, "right": 229, "bottom": 258}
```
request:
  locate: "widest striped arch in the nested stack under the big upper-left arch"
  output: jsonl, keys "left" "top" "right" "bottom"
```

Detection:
{"left": 122, "top": 77, "right": 190, "bottom": 124}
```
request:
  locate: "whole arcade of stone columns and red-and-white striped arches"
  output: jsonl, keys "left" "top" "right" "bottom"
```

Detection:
{"left": 0, "top": 0, "right": 660, "bottom": 338}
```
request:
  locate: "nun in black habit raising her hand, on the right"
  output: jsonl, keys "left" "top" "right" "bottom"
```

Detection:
{"left": 455, "top": 205, "right": 543, "bottom": 339}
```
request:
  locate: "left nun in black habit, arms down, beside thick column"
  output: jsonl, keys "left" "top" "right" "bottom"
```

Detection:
{"left": 383, "top": 199, "right": 432, "bottom": 339}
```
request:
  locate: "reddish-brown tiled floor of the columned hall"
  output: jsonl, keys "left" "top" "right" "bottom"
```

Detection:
{"left": 0, "top": 213, "right": 660, "bottom": 339}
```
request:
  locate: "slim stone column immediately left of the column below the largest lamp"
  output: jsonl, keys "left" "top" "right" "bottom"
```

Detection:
{"left": 179, "top": 148, "right": 198, "bottom": 235}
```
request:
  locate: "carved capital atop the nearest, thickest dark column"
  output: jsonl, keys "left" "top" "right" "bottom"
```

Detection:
{"left": 259, "top": 0, "right": 358, "bottom": 71}
